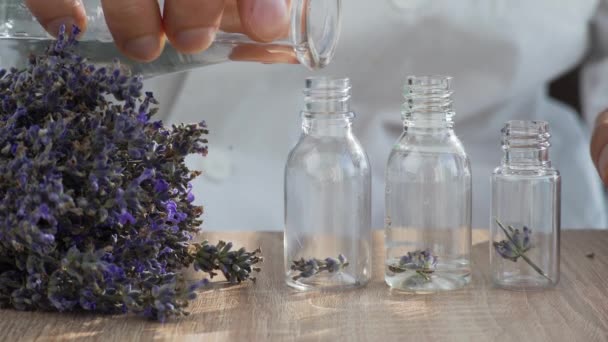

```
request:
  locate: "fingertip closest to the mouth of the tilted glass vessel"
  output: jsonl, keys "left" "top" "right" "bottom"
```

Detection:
{"left": 237, "top": 0, "right": 290, "bottom": 42}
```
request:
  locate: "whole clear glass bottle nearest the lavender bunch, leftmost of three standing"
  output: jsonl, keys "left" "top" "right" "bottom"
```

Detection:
{"left": 284, "top": 77, "right": 371, "bottom": 291}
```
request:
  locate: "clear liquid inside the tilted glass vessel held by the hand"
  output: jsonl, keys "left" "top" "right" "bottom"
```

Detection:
{"left": 0, "top": 34, "right": 305, "bottom": 78}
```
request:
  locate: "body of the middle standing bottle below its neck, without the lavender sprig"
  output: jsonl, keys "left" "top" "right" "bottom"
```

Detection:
{"left": 385, "top": 145, "right": 471, "bottom": 293}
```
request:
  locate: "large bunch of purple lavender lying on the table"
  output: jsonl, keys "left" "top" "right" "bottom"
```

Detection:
{"left": 0, "top": 28, "right": 261, "bottom": 320}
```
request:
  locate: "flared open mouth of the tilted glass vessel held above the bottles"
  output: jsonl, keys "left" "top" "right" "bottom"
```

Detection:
{"left": 291, "top": 0, "right": 341, "bottom": 70}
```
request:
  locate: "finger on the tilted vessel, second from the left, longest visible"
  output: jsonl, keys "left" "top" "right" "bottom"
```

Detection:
{"left": 101, "top": 0, "right": 164, "bottom": 62}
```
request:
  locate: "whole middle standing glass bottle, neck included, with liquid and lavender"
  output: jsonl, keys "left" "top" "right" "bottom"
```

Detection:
{"left": 385, "top": 76, "right": 471, "bottom": 293}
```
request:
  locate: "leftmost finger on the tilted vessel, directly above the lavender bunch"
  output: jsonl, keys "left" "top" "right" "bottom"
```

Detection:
{"left": 25, "top": 0, "right": 86, "bottom": 36}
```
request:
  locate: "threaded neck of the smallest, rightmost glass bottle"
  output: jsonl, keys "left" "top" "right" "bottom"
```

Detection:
{"left": 502, "top": 121, "right": 551, "bottom": 169}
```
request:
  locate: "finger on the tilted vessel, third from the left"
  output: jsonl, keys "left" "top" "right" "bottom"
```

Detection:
{"left": 163, "top": 0, "right": 224, "bottom": 53}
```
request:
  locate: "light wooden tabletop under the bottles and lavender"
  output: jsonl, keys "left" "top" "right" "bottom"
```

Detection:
{"left": 0, "top": 230, "right": 608, "bottom": 342}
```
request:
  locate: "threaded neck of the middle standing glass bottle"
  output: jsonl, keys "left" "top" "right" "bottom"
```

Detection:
{"left": 402, "top": 76, "right": 454, "bottom": 128}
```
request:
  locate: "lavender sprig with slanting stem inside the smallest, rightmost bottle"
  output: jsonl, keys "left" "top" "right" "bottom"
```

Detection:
{"left": 493, "top": 220, "right": 553, "bottom": 282}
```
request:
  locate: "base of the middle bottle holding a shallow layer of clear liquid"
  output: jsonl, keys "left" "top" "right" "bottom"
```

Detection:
{"left": 384, "top": 271, "right": 471, "bottom": 294}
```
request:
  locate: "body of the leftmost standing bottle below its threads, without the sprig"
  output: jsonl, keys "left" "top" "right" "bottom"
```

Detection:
{"left": 284, "top": 129, "right": 371, "bottom": 290}
